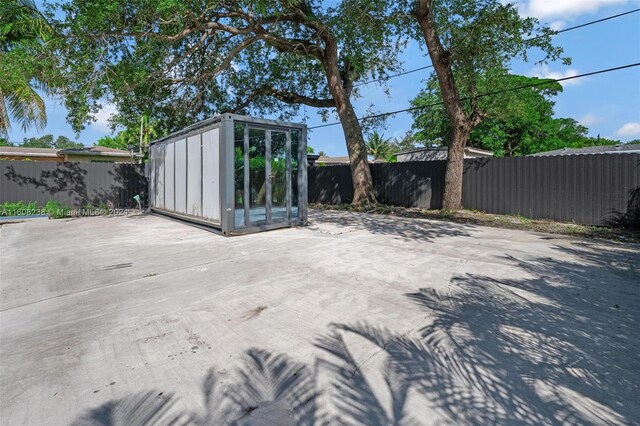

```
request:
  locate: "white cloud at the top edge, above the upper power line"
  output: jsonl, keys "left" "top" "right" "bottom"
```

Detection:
{"left": 520, "top": 0, "right": 628, "bottom": 19}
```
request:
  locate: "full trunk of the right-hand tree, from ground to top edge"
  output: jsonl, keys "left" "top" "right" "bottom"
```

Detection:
{"left": 413, "top": 0, "right": 472, "bottom": 210}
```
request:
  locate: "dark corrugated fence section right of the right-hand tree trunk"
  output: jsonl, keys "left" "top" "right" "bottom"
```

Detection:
{"left": 463, "top": 154, "right": 640, "bottom": 225}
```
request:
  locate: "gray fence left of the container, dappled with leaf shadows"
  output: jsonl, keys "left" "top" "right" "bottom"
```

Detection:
{"left": 0, "top": 161, "right": 148, "bottom": 208}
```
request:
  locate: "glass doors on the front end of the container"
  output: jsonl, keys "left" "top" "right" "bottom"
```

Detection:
{"left": 235, "top": 125, "right": 298, "bottom": 228}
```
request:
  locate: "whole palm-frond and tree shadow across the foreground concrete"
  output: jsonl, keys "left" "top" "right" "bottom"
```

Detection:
{"left": 69, "top": 243, "right": 640, "bottom": 425}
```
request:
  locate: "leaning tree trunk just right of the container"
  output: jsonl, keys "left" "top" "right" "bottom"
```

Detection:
{"left": 323, "top": 37, "right": 377, "bottom": 205}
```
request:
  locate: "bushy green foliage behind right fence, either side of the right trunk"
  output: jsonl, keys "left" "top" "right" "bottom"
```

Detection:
{"left": 412, "top": 74, "right": 617, "bottom": 157}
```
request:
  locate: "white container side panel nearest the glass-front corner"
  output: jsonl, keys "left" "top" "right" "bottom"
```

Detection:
{"left": 202, "top": 128, "right": 220, "bottom": 221}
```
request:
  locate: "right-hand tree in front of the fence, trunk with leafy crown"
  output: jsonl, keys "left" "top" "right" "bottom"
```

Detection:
{"left": 402, "top": 0, "right": 568, "bottom": 210}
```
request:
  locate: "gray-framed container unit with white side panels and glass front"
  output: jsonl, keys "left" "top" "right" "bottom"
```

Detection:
{"left": 149, "top": 114, "right": 307, "bottom": 236}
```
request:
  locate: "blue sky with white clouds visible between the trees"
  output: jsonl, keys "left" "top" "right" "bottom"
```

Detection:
{"left": 9, "top": 0, "right": 640, "bottom": 156}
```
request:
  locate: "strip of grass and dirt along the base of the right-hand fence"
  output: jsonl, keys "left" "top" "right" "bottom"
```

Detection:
{"left": 310, "top": 204, "right": 640, "bottom": 243}
